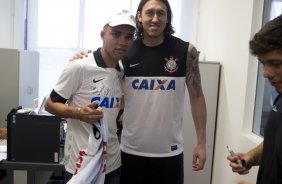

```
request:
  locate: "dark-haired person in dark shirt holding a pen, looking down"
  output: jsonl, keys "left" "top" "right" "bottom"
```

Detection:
{"left": 227, "top": 15, "right": 282, "bottom": 184}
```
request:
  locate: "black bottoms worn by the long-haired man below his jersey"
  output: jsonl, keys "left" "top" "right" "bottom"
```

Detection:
{"left": 120, "top": 152, "right": 184, "bottom": 184}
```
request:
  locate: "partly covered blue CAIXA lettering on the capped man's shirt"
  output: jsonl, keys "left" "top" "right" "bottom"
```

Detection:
{"left": 91, "top": 96, "right": 120, "bottom": 109}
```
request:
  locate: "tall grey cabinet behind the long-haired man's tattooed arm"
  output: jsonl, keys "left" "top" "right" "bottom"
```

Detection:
{"left": 183, "top": 62, "right": 220, "bottom": 184}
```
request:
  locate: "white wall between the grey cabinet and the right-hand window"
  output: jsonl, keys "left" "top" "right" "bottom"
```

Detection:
{"left": 196, "top": 0, "right": 263, "bottom": 184}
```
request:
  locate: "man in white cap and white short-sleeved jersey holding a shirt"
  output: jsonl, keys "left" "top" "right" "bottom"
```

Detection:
{"left": 45, "top": 10, "right": 136, "bottom": 184}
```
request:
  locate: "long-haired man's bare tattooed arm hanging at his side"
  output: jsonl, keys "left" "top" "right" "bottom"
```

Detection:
{"left": 186, "top": 44, "right": 207, "bottom": 171}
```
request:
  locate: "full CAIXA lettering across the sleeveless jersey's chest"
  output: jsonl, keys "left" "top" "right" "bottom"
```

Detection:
{"left": 132, "top": 79, "right": 175, "bottom": 90}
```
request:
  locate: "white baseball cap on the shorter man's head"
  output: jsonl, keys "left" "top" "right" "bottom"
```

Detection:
{"left": 105, "top": 10, "right": 136, "bottom": 29}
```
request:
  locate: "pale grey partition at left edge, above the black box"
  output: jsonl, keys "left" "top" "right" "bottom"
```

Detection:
{"left": 0, "top": 49, "right": 39, "bottom": 127}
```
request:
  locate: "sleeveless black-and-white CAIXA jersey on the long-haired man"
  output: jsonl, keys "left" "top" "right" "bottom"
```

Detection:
{"left": 121, "top": 36, "right": 188, "bottom": 157}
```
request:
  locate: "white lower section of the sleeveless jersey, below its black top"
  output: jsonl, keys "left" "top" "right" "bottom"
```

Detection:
{"left": 122, "top": 77, "right": 185, "bottom": 157}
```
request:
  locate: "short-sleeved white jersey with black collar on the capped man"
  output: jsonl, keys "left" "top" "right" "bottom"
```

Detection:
{"left": 54, "top": 50, "right": 122, "bottom": 173}
